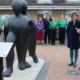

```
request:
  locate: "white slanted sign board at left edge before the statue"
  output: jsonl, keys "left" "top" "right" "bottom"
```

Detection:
{"left": 0, "top": 42, "right": 13, "bottom": 57}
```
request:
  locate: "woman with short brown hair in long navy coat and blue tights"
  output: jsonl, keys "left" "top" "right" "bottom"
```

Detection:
{"left": 67, "top": 12, "right": 80, "bottom": 67}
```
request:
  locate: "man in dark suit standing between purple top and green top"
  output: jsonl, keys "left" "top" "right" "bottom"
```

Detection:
{"left": 43, "top": 15, "right": 52, "bottom": 44}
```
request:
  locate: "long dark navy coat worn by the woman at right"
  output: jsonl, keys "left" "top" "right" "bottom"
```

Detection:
{"left": 67, "top": 20, "right": 80, "bottom": 49}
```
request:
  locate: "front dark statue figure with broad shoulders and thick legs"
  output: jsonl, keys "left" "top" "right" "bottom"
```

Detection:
{"left": 4, "top": 0, "right": 36, "bottom": 77}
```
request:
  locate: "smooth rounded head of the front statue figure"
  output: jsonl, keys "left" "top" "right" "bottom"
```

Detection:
{"left": 12, "top": 0, "right": 22, "bottom": 15}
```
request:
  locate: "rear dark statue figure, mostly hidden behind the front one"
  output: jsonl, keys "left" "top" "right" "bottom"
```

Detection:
{"left": 21, "top": 0, "right": 38, "bottom": 63}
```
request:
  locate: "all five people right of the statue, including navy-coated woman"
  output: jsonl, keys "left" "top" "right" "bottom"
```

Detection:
{"left": 36, "top": 12, "right": 80, "bottom": 67}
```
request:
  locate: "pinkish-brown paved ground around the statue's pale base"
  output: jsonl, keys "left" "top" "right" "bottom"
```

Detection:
{"left": 0, "top": 35, "right": 80, "bottom": 80}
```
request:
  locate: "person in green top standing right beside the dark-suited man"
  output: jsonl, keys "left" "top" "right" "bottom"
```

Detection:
{"left": 49, "top": 17, "right": 57, "bottom": 45}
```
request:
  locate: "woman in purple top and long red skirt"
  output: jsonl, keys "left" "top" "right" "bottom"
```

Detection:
{"left": 36, "top": 18, "right": 44, "bottom": 44}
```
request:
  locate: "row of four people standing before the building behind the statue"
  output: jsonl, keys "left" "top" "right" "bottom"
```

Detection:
{"left": 36, "top": 15, "right": 67, "bottom": 45}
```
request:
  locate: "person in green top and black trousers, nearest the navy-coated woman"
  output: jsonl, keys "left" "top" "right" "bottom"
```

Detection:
{"left": 58, "top": 15, "right": 67, "bottom": 45}
